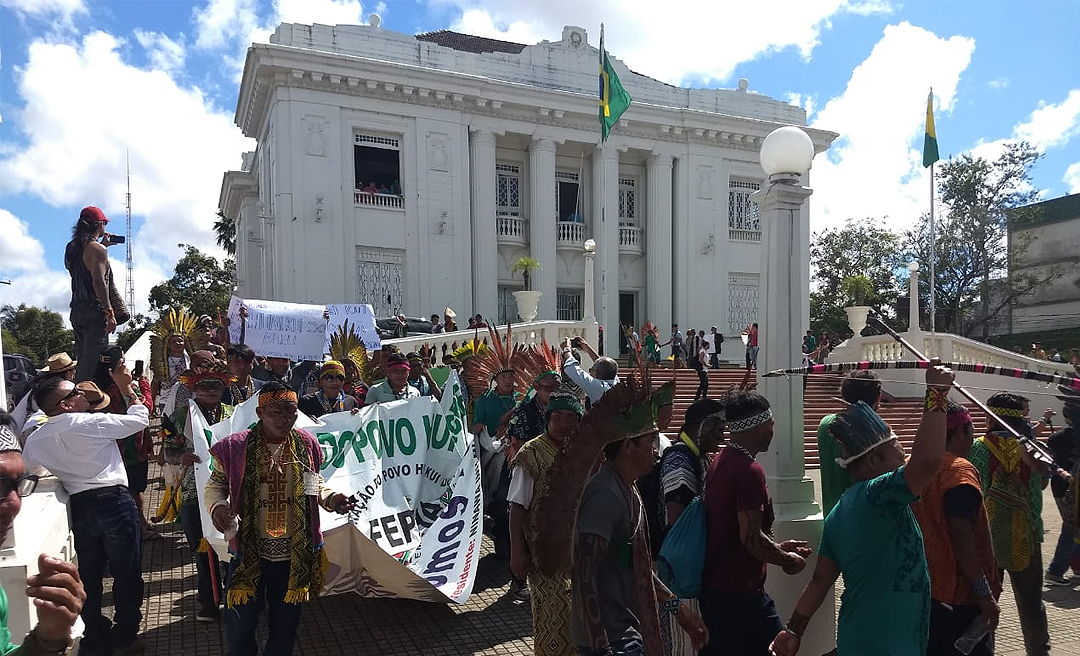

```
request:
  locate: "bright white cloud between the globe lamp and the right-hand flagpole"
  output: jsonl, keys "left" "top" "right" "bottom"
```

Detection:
{"left": 811, "top": 23, "right": 975, "bottom": 231}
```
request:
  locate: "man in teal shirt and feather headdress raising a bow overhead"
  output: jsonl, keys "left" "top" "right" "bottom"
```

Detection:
{"left": 771, "top": 360, "right": 953, "bottom": 656}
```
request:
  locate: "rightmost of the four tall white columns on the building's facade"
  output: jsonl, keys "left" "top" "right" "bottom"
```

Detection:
{"left": 645, "top": 155, "right": 672, "bottom": 332}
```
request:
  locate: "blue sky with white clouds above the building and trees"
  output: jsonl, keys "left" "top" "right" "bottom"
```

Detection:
{"left": 0, "top": 0, "right": 1080, "bottom": 314}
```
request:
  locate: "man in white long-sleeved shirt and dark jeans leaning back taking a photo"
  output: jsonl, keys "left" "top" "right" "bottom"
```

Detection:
{"left": 23, "top": 365, "right": 149, "bottom": 656}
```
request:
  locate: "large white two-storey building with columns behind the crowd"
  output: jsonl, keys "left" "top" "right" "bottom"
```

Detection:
{"left": 220, "top": 21, "right": 836, "bottom": 350}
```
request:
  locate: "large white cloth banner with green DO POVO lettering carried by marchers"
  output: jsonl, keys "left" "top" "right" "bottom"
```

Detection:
{"left": 188, "top": 374, "right": 484, "bottom": 603}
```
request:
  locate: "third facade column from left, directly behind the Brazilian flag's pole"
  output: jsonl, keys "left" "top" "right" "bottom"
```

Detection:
{"left": 592, "top": 145, "right": 619, "bottom": 357}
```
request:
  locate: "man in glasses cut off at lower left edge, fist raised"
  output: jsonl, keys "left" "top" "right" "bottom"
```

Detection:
{"left": 0, "top": 412, "right": 86, "bottom": 656}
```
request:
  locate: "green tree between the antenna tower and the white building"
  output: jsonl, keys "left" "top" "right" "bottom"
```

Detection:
{"left": 150, "top": 246, "right": 237, "bottom": 317}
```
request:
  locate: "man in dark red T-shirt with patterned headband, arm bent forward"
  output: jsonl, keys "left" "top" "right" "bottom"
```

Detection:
{"left": 701, "top": 391, "right": 810, "bottom": 656}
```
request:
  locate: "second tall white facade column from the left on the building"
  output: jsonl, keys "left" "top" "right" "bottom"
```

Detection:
{"left": 529, "top": 138, "right": 557, "bottom": 321}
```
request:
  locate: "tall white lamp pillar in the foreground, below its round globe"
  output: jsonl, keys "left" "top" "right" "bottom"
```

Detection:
{"left": 751, "top": 182, "right": 835, "bottom": 654}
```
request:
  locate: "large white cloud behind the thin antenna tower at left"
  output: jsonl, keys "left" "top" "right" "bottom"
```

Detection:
{"left": 0, "top": 32, "right": 252, "bottom": 283}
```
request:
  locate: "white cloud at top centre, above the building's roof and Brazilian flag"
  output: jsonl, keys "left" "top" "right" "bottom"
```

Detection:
{"left": 432, "top": 0, "right": 889, "bottom": 84}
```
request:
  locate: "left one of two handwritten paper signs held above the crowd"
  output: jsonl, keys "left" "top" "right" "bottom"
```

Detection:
{"left": 229, "top": 296, "right": 326, "bottom": 362}
